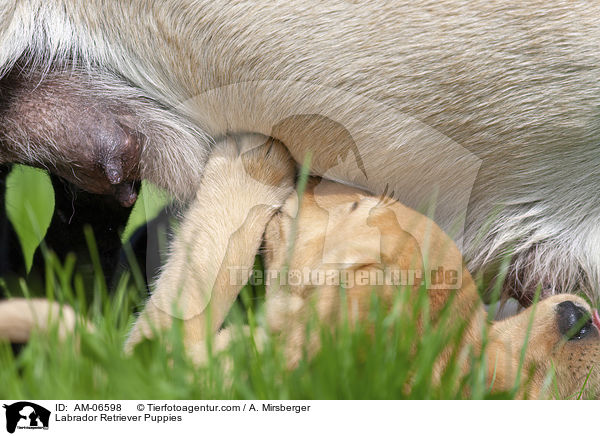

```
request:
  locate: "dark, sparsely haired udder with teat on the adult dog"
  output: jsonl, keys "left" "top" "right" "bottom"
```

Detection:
{"left": 0, "top": 71, "right": 144, "bottom": 206}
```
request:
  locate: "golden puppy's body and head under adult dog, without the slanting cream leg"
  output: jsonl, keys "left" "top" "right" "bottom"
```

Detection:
{"left": 265, "top": 178, "right": 600, "bottom": 398}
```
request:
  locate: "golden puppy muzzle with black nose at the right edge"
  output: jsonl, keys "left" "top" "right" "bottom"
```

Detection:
{"left": 488, "top": 294, "right": 600, "bottom": 399}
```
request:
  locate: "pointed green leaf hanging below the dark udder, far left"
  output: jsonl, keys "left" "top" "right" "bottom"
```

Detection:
{"left": 5, "top": 165, "right": 54, "bottom": 272}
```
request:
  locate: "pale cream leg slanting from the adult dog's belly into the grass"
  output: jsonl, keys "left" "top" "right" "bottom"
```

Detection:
{"left": 126, "top": 135, "right": 295, "bottom": 350}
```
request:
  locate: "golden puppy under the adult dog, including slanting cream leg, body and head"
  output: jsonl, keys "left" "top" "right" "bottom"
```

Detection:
{"left": 126, "top": 135, "right": 600, "bottom": 398}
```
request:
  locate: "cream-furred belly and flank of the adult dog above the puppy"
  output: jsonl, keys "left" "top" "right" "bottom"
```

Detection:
{"left": 0, "top": 0, "right": 600, "bottom": 300}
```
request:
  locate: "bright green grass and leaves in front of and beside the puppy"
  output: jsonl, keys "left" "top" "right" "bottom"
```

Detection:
{"left": 0, "top": 165, "right": 536, "bottom": 399}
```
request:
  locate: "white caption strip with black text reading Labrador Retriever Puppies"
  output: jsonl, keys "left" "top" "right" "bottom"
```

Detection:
{"left": 0, "top": 400, "right": 596, "bottom": 436}
